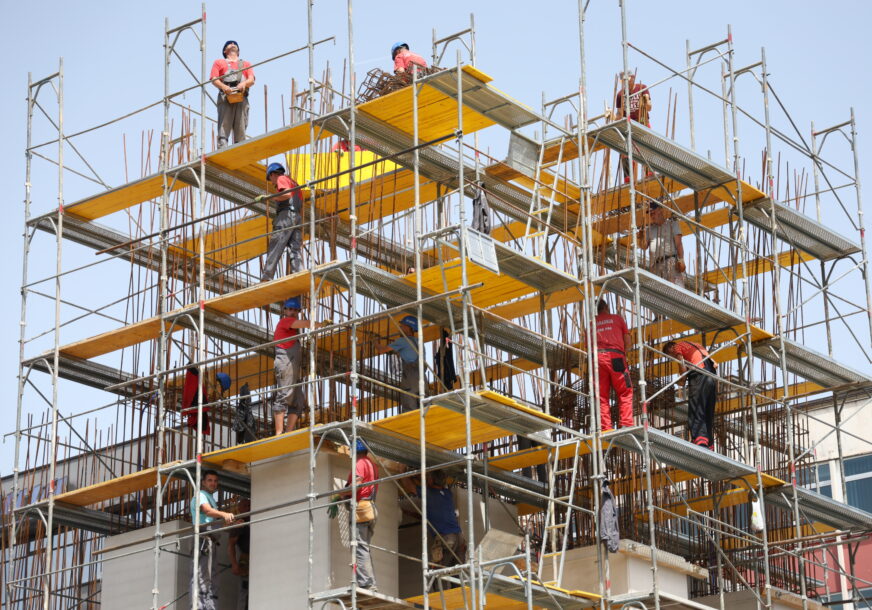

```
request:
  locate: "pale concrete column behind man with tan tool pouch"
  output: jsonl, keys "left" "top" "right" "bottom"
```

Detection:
{"left": 250, "top": 452, "right": 400, "bottom": 608}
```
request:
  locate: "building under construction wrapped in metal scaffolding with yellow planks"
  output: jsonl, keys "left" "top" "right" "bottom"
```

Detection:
{"left": 2, "top": 0, "right": 872, "bottom": 610}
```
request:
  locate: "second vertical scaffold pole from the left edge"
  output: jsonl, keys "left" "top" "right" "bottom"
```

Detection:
{"left": 42, "top": 57, "right": 64, "bottom": 610}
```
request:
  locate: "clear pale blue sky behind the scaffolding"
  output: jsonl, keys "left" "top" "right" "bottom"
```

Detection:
{"left": 0, "top": 0, "right": 872, "bottom": 466}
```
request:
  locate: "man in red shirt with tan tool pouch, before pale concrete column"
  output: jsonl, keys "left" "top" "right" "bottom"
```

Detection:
{"left": 332, "top": 439, "right": 378, "bottom": 591}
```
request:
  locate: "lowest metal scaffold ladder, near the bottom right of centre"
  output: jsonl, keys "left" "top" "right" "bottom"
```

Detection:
{"left": 537, "top": 438, "right": 581, "bottom": 587}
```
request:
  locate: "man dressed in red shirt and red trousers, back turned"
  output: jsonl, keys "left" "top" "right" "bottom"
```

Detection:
{"left": 595, "top": 299, "right": 633, "bottom": 432}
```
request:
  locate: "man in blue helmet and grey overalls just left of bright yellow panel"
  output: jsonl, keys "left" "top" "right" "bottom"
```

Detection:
{"left": 255, "top": 163, "right": 303, "bottom": 282}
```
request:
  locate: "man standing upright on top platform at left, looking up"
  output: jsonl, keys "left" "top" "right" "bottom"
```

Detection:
{"left": 209, "top": 40, "right": 254, "bottom": 148}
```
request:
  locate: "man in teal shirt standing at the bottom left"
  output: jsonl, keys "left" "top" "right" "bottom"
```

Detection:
{"left": 191, "top": 470, "right": 233, "bottom": 610}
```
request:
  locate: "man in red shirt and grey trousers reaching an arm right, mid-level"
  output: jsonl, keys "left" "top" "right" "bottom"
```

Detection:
{"left": 272, "top": 297, "right": 323, "bottom": 435}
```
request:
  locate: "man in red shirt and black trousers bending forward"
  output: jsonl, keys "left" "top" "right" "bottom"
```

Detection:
{"left": 663, "top": 341, "right": 718, "bottom": 449}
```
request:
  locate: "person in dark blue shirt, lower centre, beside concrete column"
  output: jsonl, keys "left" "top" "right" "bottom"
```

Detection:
{"left": 400, "top": 470, "right": 466, "bottom": 567}
